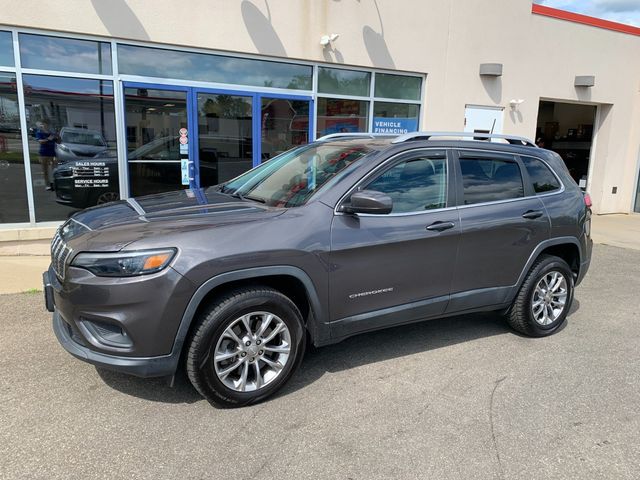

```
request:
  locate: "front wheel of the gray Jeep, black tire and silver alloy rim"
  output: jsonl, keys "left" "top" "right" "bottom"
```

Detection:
{"left": 186, "top": 287, "right": 306, "bottom": 408}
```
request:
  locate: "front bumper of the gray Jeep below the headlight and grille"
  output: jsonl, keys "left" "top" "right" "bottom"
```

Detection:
{"left": 43, "top": 267, "right": 192, "bottom": 377}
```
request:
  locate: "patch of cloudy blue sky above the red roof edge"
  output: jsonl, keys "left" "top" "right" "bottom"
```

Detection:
{"left": 534, "top": 0, "right": 640, "bottom": 27}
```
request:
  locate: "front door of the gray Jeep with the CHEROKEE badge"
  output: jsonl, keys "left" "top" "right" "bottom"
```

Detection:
{"left": 329, "top": 149, "right": 460, "bottom": 337}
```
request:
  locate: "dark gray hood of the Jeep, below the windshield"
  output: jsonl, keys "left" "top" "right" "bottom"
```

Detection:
{"left": 60, "top": 188, "right": 285, "bottom": 252}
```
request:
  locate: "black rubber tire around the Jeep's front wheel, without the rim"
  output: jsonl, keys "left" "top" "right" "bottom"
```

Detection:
{"left": 194, "top": 291, "right": 306, "bottom": 407}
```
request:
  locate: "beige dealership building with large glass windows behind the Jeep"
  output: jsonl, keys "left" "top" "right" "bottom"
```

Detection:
{"left": 0, "top": 0, "right": 640, "bottom": 234}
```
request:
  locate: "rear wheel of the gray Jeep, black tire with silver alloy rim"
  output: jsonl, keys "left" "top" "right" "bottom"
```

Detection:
{"left": 507, "top": 255, "right": 574, "bottom": 337}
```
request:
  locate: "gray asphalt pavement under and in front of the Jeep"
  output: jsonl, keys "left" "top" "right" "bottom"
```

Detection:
{"left": 0, "top": 246, "right": 640, "bottom": 480}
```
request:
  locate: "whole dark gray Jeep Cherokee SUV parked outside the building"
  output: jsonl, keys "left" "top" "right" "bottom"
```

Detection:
{"left": 44, "top": 132, "right": 592, "bottom": 407}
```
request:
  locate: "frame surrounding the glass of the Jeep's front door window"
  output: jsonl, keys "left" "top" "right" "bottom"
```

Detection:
{"left": 334, "top": 147, "right": 457, "bottom": 218}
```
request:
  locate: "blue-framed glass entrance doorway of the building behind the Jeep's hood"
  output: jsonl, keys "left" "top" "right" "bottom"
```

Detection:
{"left": 123, "top": 83, "right": 313, "bottom": 196}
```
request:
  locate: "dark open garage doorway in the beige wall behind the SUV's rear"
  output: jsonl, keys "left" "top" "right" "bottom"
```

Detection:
{"left": 536, "top": 100, "right": 597, "bottom": 189}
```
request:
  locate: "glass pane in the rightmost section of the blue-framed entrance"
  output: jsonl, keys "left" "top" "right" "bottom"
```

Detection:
{"left": 260, "top": 97, "right": 309, "bottom": 161}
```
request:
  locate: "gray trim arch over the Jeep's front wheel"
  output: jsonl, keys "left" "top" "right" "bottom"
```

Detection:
{"left": 171, "top": 265, "right": 328, "bottom": 368}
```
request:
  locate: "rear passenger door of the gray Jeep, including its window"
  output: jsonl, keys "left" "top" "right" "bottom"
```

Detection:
{"left": 448, "top": 150, "right": 550, "bottom": 311}
